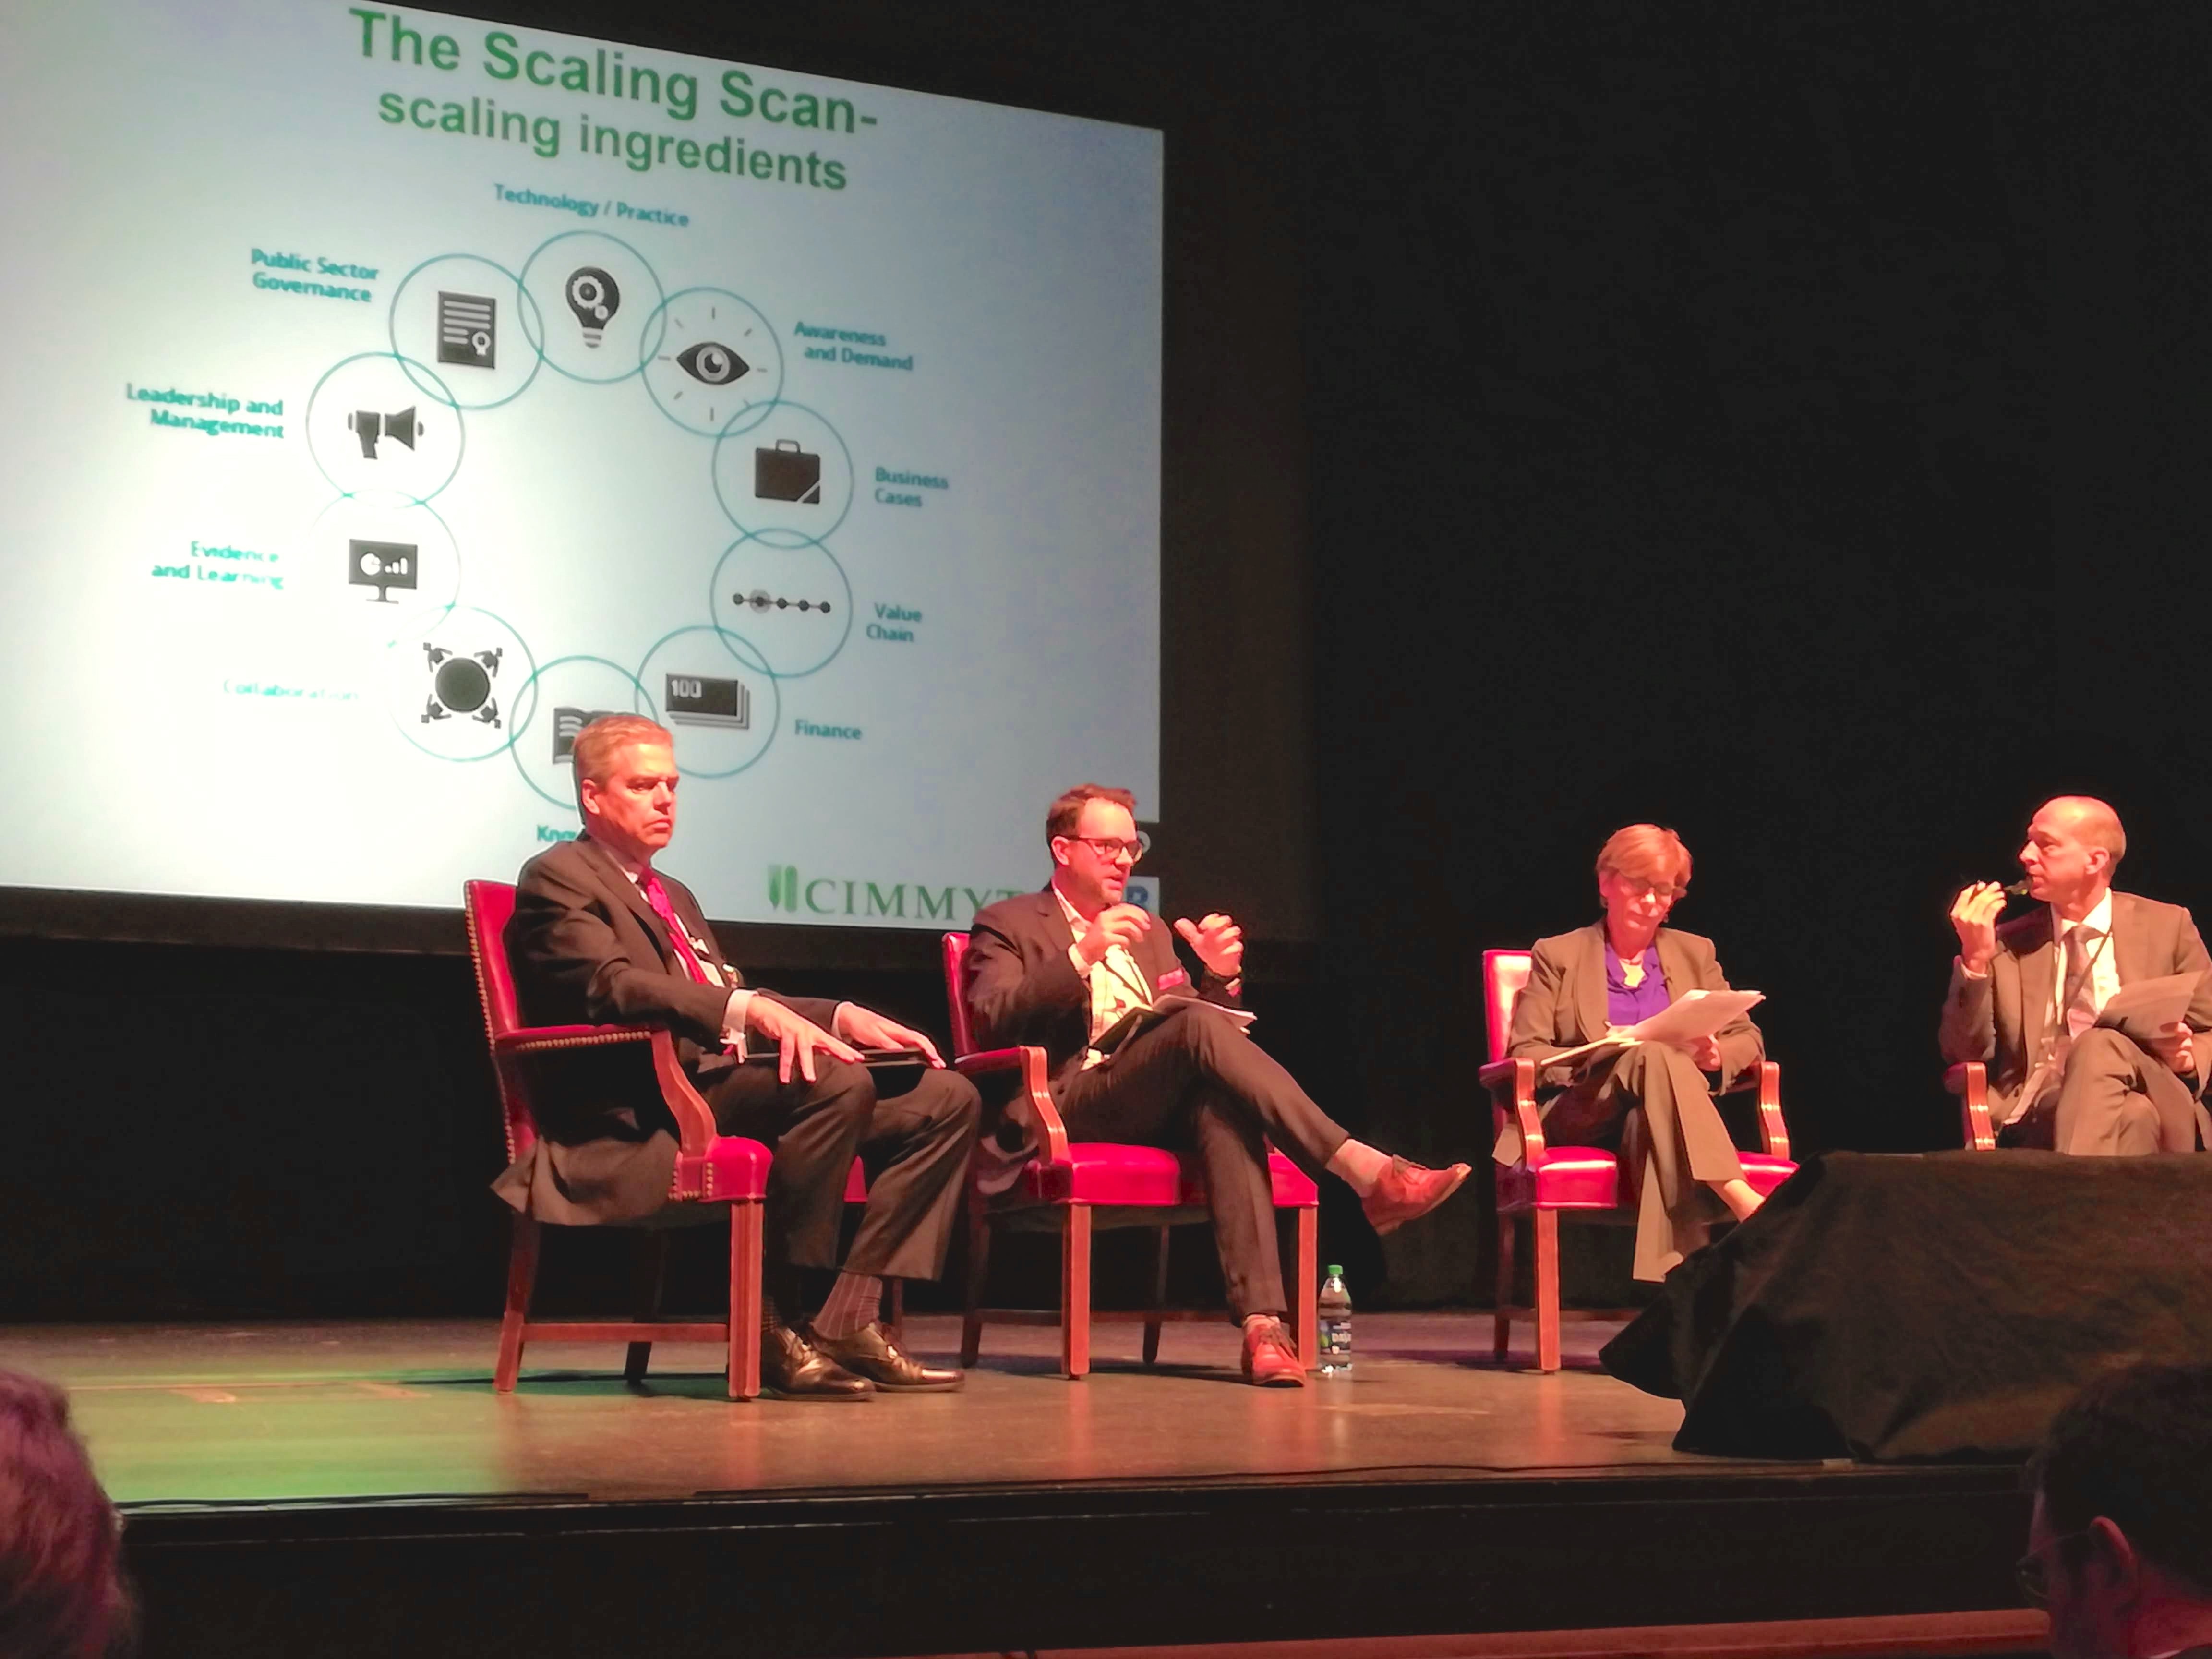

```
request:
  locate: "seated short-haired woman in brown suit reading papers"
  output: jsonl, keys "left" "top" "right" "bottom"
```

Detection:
{"left": 1495, "top": 823, "right": 1765, "bottom": 1278}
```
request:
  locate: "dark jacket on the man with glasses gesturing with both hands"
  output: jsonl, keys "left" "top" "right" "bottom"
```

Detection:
{"left": 960, "top": 887, "right": 1238, "bottom": 1095}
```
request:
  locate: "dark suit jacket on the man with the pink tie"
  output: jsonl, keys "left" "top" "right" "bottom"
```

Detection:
{"left": 493, "top": 836, "right": 836, "bottom": 1226}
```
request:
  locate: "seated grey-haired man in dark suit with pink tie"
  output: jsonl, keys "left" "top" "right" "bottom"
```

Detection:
{"left": 495, "top": 714, "right": 980, "bottom": 1398}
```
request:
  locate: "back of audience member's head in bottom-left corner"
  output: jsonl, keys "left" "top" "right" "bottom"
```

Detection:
{"left": 0, "top": 1371, "right": 131, "bottom": 1659}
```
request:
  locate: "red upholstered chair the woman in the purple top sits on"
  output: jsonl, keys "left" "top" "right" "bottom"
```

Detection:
{"left": 1480, "top": 951, "right": 1796, "bottom": 1371}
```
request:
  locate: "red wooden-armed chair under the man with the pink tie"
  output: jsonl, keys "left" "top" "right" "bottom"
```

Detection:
{"left": 462, "top": 880, "right": 774, "bottom": 1400}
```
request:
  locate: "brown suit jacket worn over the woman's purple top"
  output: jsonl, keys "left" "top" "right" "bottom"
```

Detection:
{"left": 1495, "top": 923, "right": 1767, "bottom": 1164}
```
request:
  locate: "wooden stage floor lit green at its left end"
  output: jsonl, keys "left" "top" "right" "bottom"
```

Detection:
{"left": 30, "top": 1314, "right": 1741, "bottom": 1506}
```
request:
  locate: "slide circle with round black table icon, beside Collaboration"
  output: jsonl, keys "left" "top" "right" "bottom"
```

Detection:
{"left": 378, "top": 606, "right": 538, "bottom": 761}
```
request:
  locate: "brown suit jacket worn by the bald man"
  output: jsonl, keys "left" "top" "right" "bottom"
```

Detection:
{"left": 1936, "top": 891, "right": 2212, "bottom": 1124}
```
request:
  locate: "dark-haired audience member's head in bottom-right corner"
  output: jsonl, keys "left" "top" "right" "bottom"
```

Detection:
{"left": 2017, "top": 1365, "right": 2212, "bottom": 1659}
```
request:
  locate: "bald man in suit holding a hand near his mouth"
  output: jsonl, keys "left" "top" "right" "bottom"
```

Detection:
{"left": 1940, "top": 796, "right": 2212, "bottom": 1157}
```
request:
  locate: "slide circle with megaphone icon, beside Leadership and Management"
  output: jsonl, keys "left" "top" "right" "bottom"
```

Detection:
{"left": 308, "top": 352, "right": 462, "bottom": 502}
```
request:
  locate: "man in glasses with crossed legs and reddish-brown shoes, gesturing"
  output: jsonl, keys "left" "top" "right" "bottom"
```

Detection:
{"left": 962, "top": 783, "right": 1467, "bottom": 1385}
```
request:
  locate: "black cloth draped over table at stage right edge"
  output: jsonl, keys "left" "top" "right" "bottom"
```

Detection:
{"left": 1599, "top": 1153, "right": 2212, "bottom": 1462}
